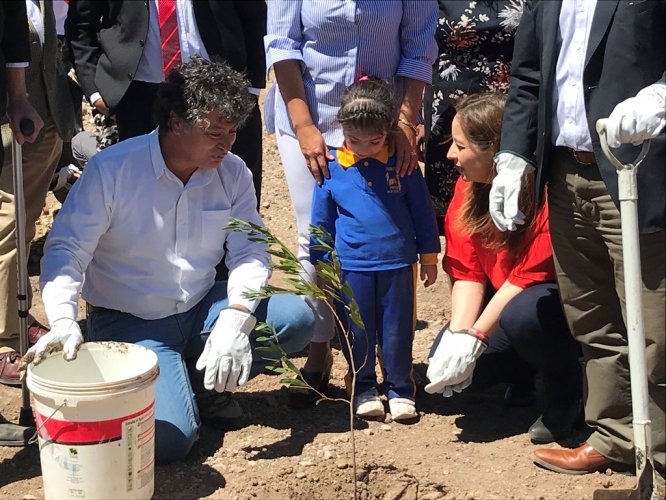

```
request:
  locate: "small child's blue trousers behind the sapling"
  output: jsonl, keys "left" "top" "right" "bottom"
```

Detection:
{"left": 338, "top": 266, "right": 416, "bottom": 399}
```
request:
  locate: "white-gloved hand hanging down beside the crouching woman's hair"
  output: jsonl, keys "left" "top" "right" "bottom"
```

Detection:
{"left": 488, "top": 151, "right": 534, "bottom": 231}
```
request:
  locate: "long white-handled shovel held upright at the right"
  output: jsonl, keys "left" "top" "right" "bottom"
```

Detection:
{"left": 597, "top": 119, "right": 655, "bottom": 499}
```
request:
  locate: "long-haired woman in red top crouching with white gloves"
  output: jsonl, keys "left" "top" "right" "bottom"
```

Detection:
{"left": 426, "top": 93, "right": 582, "bottom": 443}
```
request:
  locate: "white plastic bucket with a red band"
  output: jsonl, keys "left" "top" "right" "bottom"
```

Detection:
{"left": 27, "top": 342, "right": 159, "bottom": 500}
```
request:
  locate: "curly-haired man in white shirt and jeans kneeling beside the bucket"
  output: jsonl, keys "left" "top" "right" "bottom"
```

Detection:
{"left": 25, "top": 58, "right": 314, "bottom": 462}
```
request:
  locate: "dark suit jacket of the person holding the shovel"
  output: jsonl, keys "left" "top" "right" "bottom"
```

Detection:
{"left": 501, "top": 0, "right": 666, "bottom": 233}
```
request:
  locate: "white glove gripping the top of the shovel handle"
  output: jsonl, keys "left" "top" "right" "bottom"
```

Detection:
{"left": 606, "top": 83, "right": 666, "bottom": 148}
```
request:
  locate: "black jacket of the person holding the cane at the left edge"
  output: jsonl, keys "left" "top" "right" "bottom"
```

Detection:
{"left": 0, "top": 0, "right": 30, "bottom": 118}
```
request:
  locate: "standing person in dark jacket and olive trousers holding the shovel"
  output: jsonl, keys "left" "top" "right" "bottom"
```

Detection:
{"left": 489, "top": 0, "right": 666, "bottom": 475}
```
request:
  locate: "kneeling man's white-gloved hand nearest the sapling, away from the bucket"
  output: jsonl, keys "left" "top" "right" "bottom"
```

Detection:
{"left": 196, "top": 308, "right": 257, "bottom": 392}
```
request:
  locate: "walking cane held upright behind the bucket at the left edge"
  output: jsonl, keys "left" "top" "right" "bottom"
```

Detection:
{"left": 12, "top": 118, "right": 35, "bottom": 427}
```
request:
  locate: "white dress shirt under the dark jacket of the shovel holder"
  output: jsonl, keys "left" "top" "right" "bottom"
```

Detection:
{"left": 552, "top": 0, "right": 597, "bottom": 151}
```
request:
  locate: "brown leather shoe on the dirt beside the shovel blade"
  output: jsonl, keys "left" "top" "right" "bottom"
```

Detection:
{"left": 532, "top": 443, "right": 629, "bottom": 474}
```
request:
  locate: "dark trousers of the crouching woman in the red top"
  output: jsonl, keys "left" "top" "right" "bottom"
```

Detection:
{"left": 452, "top": 283, "right": 583, "bottom": 407}
